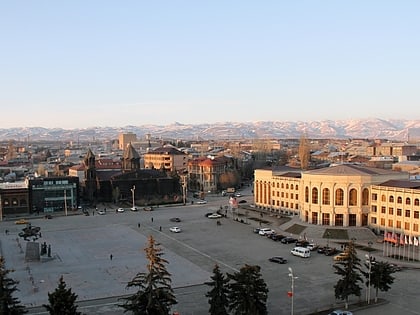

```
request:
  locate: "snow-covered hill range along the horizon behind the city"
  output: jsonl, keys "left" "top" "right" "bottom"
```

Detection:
{"left": 0, "top": 118, "right": 420, "bottom": 141}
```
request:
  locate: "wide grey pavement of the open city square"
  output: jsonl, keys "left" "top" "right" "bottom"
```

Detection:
{"left": 0, "top": 193, "right": 417, "bottom": 315}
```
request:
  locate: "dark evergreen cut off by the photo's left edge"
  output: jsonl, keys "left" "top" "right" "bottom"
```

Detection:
{"left": 0, "top": 256, "right": 28, "bottom": 315}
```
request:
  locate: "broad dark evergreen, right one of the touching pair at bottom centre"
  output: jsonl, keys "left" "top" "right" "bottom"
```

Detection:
{"left": 227, "top": 265, "right": 268, "bottom": 315}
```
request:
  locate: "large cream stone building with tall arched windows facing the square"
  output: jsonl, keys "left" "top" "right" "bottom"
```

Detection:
{"left": 254, "top": 164, "right": 412, "bottom": 231}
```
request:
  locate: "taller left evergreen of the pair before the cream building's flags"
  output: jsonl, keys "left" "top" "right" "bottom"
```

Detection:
{"left": 333, "top": 242, "right": 362, "bottom": 309}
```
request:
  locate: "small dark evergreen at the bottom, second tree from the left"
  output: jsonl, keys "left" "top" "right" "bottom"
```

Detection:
{"left": 42, "top": 276, "right": 81, "bottom": 315}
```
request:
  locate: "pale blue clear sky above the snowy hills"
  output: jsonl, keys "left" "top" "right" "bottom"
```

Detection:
{"left": 0, "top": 0, "right": 420, "bottom": 129}
